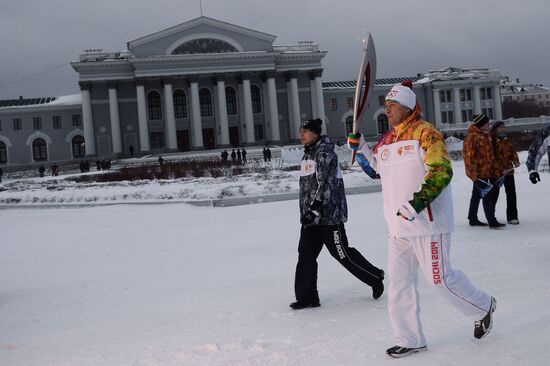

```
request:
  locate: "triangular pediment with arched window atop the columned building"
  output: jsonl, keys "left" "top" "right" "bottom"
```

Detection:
{"left": 128, "top": 17, "right": 276, "bottom": 57}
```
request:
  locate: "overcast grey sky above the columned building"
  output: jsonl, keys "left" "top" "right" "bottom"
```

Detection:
{"left": 0, "top": 0, "right": 550, "bottom": 99}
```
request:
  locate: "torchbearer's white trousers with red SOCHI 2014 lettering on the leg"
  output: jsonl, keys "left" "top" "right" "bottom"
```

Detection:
{"left": 388, "top": 234, "right": 491, "bottom": 348}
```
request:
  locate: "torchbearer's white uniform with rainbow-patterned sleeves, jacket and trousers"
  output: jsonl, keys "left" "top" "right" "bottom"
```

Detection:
{"left": 350, "top": 100, "right": 498, "bottom": 349}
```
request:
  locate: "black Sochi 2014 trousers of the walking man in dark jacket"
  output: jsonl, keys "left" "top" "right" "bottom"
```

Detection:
{"left": 294, "top": 224, "right": 382, "bottom": 302}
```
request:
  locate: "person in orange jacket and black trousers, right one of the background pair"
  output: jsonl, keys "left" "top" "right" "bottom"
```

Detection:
{"left": 491, "top": 121, "right": 520, "bottom": 225}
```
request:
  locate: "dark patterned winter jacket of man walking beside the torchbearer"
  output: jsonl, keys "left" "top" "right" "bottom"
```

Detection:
{"left": 300, "top": 136, "right": 348, "bottom": 225}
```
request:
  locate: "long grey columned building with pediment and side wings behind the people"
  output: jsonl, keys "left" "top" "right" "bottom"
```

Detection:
{"left": 0, "top": 17, "right": 544, "bottom": 165}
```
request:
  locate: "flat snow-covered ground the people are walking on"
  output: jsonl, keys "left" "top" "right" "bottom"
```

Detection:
{"left": 0, "top": 155, "right": 550, "bottom": 366}
